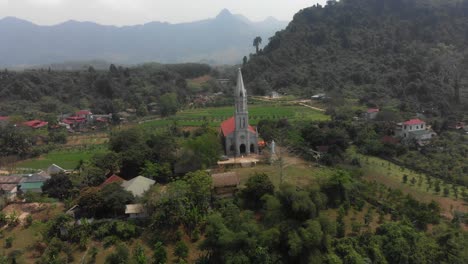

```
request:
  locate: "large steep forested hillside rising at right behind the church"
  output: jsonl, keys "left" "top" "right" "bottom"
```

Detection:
{"left": 244, "top": 0, "right": 468, "bottom": 114}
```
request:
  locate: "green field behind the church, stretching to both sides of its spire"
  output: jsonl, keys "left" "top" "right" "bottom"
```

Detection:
{"left": 142, "top": 104, "right": 329, "bottom": 129}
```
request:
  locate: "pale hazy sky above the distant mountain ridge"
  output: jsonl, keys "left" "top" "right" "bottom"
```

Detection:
{"left": 0, "top": 0, "right": 326, "bottom": 25}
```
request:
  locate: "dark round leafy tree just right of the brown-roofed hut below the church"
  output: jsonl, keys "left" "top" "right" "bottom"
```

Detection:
{"left": 241, "top": 173, "right": 275, "bottom": 209}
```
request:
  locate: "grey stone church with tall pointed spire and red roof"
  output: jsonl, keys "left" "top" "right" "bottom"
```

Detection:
{"left": 221, "top": 69, "right": 258, "bottom": 156}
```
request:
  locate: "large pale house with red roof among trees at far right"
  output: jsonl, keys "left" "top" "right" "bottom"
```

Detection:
{"left": 395, "top": 119, "right": 437, "bottom": 144}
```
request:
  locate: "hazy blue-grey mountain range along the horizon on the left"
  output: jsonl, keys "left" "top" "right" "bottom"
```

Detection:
{"left": 0, "top": 9, "right": 287, "bottom": 67}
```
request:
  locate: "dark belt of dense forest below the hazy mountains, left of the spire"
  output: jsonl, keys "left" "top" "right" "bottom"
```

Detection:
{"left": 0, "top": 64, "right": 212, "bottom": 116}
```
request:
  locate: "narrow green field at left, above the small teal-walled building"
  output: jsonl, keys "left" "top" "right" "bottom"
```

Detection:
{"left": 16, "top": 145, "right": 107, "bottom": 169}
